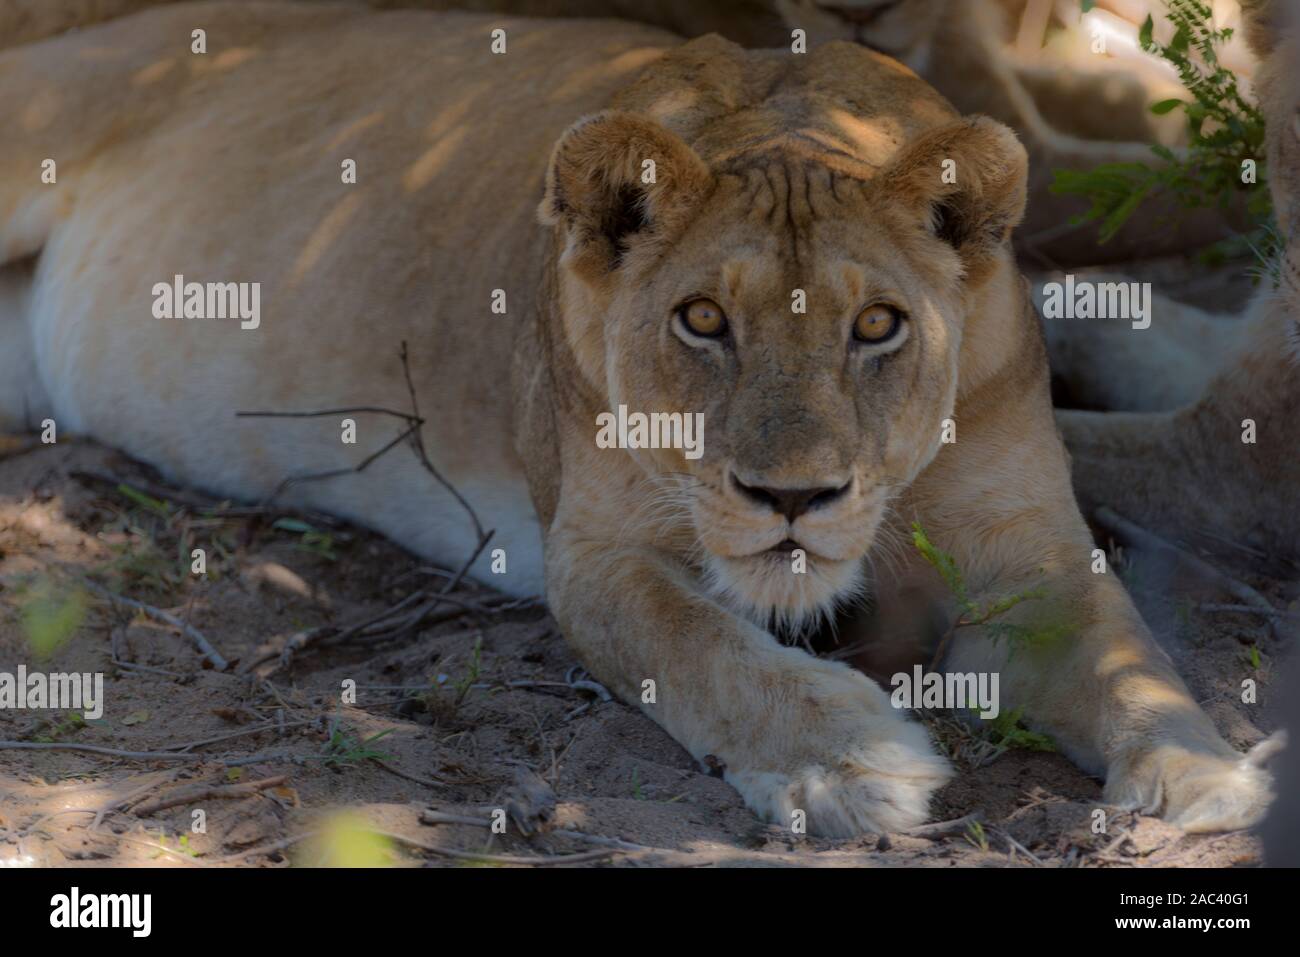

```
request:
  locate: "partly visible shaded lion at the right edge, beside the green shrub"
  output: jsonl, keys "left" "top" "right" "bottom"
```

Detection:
{"left": 1053, "top": 3, "right": 1300, "bottom": 558}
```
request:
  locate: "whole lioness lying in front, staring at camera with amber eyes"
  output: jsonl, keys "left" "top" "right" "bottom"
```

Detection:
{"left": 0, "top": 4, "right": 1269, "bottom": 835}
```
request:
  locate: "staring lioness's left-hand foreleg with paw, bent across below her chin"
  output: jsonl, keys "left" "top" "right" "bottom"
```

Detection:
{"left": 547, "top": 529, "right": 950, "bottom": 836}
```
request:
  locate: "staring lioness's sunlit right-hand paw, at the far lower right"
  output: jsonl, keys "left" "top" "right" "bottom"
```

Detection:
{"left": 1106, "top": 739, "right": 1279, "bottom": 832}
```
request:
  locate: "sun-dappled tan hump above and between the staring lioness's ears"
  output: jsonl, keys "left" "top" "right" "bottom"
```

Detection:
{"left": 614, "top": 35, "right": 958, "bottom": 177}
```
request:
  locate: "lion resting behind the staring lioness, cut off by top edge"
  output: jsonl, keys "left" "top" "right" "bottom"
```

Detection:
{"left": 0, "top": 0, "right": 1227, "bottom": 265}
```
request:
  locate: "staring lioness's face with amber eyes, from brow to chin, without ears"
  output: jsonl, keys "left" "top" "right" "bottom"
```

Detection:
{"left": 606, "top": 162, "right": 962, "bottom": 627}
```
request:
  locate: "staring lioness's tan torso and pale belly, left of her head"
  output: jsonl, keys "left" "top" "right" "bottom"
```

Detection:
{"left": 0, "top": 5, "right": 680, "bottom": 594}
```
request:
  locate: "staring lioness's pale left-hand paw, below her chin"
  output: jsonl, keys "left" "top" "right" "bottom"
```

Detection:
{"left": 727, "top": 718, "right": 952, "bottom": 837}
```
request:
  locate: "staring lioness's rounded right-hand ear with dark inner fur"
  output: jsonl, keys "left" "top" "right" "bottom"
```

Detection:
{"left": 878, "top": 117, "right": 1028, "bottom": 268}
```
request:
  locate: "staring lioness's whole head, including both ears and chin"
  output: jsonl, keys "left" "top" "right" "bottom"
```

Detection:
{"left": 541, "top": 36, "right": 1026, "bottom": 627}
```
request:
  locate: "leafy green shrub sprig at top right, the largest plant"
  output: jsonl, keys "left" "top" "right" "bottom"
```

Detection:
{"left": 1052, "top": 0, "right": 1278, "bottom": 264}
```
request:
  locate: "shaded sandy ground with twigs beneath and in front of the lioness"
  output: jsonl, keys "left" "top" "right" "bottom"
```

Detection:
{"left": 0, "top": 441, "right": 1300, "bottom": 867}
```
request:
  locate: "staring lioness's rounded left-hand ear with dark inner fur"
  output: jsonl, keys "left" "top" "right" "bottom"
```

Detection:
{"left": 538, "top": 111, "right": 712, "bottom": 273}
